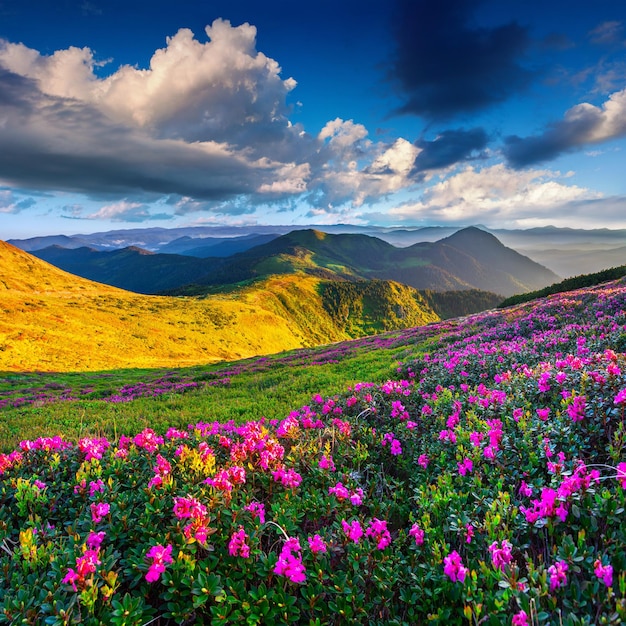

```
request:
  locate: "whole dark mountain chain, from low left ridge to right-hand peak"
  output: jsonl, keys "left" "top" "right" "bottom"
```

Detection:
{"left": 25, "top": 227, "right": 559, "bottom": 297}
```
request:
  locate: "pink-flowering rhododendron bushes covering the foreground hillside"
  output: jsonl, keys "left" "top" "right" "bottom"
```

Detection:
{"left": 0, "top": 283, "right": 626, "bottom": 626}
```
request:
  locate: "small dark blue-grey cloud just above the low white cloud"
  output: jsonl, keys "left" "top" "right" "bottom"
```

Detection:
{"left": 413, "top": 128, "right": 489, "bottom": 173}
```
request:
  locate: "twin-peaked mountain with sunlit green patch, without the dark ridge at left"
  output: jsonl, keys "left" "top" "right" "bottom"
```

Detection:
{"left": 173, "top": 227, "right": 559, "bottom": 296}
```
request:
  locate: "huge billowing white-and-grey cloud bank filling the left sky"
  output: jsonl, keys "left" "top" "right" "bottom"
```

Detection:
{"left": 0, "top": 19, "right": 428, "bottom": 220}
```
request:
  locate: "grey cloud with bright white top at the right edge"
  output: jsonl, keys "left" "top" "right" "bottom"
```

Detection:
{"left": 504, "top": 89, "right": 626, "bottom": 168}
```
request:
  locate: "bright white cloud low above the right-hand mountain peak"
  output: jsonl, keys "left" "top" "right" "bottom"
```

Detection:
{"left": 388, "top": 164, "right": 600, "bottom": 227}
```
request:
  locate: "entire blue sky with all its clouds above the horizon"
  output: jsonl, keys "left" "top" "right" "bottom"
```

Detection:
{"left": 0, "top": 0, "right": 626, "bottom": 239}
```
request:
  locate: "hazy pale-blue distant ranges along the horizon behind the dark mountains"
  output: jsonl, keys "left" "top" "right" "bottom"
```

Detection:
{"left": 8, "top": 224, "right": 626, "bottom": 278}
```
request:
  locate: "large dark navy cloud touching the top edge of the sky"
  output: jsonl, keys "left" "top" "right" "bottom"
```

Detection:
{"left": 391, "top": 0, "right": 533, "bottom": 120}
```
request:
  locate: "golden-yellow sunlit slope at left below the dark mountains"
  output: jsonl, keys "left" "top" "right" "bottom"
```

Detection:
{"left": 0, "top": 242, "right": 437, "bottom": 371}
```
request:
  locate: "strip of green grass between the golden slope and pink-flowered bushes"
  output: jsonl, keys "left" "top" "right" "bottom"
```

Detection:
{"left": 0, "top": 333, "right": 428, "bottom": 452}
